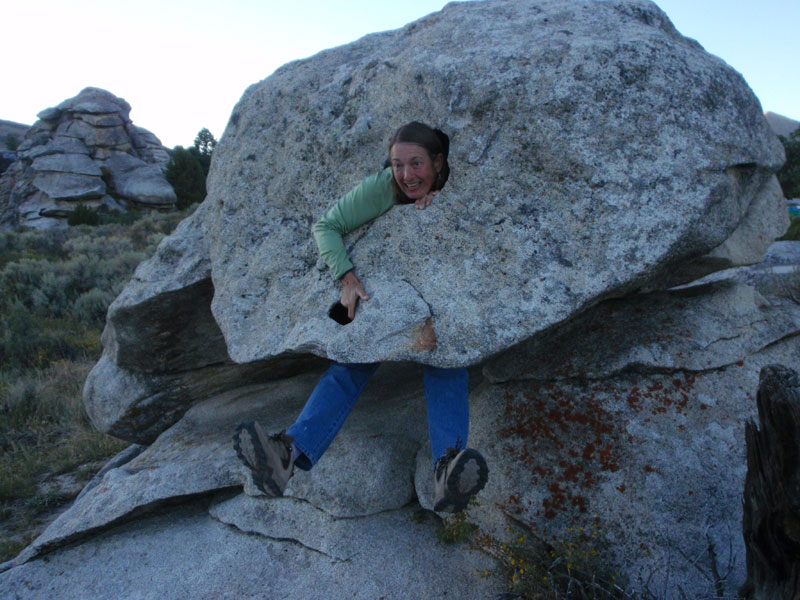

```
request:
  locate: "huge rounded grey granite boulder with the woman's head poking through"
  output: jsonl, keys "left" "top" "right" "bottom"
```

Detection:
{"left": 206, "top": 1, "right": 787, "bottom": 366}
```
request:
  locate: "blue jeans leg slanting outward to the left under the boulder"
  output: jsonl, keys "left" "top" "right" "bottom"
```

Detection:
{"left": 286, "top": 363, "right": 380, "bottom": 471}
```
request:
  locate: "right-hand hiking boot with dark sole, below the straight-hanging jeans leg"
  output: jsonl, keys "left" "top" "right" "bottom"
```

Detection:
{"left": 433, "top": 448, "right": 489, "bottom": 513}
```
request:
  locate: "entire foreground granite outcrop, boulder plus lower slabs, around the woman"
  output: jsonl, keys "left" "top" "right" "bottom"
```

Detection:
{"left": 0, "top": 0, "right": 800, "bottom": 599}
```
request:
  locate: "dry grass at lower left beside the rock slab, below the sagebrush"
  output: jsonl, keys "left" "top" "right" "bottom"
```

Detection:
{"left": 0, "top": 361, "right": 126, "bottom": 561}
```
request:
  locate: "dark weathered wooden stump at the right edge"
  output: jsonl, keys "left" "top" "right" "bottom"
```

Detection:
{"left": 741, "top": 365, "right": 800, "bottom": 600}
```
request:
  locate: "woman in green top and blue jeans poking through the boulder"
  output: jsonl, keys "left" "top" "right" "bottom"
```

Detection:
{"left": 234, "top": 121, "right": 488, "bottom": 512}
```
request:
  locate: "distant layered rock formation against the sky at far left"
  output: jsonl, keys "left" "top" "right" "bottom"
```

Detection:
{"left": 0, "top": 88, "right": 176, "bottom": 229}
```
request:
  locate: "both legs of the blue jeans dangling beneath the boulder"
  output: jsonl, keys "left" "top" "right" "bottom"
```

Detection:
{"left": 287, "top": 363, "right": 469, "bottom": 471}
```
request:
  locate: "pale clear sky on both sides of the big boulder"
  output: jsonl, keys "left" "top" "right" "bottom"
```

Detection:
{"left": 0, "top": 0, "right": 800, "bottom": 148}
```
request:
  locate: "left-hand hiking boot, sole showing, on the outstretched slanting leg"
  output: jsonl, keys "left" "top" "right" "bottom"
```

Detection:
{"left": 233, "top": 421, "right": 294, "bottom": 497}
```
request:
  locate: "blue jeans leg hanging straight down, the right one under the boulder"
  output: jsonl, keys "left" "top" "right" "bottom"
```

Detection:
{"left": 425, "top": 365, "right": 469, "bottom": 464}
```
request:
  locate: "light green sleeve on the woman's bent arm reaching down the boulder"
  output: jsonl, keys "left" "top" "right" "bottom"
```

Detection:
{"left": 313, "top": 168, "right": 394, "bottom": 279}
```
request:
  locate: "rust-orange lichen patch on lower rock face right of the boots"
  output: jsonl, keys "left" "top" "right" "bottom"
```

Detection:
{"left": 498, "top": 373, "right": 709, "bottom": 519}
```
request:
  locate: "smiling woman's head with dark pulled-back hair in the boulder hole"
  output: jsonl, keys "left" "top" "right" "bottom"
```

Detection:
{"left": 387, "top": 121, "right": 450, "bottom": 203}
